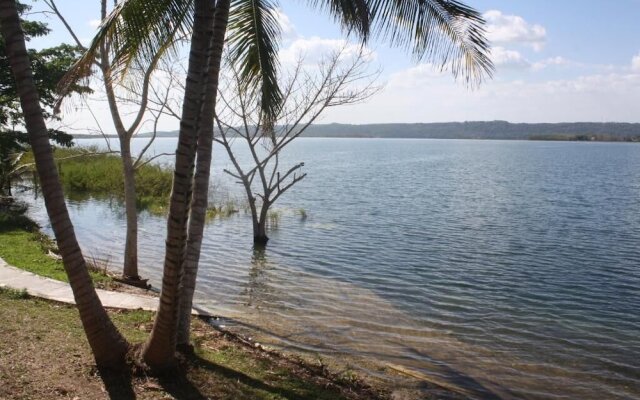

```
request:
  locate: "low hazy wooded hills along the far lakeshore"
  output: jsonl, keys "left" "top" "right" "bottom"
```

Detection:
{"left": 76, "top": 121, "right": 640, "bottom": 141}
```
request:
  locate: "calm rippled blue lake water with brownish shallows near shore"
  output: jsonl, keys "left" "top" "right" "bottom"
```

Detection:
{"left": 13, "top": 139, "right": 640, "bottom": 399}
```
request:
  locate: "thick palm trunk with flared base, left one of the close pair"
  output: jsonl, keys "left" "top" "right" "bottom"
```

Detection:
{"left": 142, "top": 0, "right": 215, "bottom": 370}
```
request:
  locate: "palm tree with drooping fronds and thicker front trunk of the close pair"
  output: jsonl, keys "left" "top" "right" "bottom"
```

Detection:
{"left": 66, "top": 0, "right": 493, "bottom": 368}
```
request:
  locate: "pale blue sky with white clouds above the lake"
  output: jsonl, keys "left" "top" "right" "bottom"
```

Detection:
{"left": 22, "top": 0, "right": 640, "bottom": 132}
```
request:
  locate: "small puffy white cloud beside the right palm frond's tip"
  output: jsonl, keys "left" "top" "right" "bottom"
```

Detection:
{"left": 484, "top": 10, "right": 547, "bottom": 51}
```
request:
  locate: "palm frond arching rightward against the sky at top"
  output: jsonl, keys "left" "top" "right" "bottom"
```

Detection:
{"left": 368, "top": 0, "right": 494, "bottom": 85}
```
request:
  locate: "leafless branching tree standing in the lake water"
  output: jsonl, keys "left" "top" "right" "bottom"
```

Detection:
{"left": 214, "top": 46, "right": 379, "bottom": 246}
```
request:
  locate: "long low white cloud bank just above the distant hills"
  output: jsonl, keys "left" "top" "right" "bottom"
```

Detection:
{"left": 323, "top": 64, "right": 640, "bottom": 123}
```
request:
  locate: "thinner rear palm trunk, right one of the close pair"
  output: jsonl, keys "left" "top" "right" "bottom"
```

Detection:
{"left": 178, "top": 0, "right": 230, "bottom": 347}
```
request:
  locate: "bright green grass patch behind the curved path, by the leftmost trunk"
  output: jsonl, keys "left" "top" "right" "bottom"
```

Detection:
{"left": 0, "top": 204, "right": 111, "bottom": 283}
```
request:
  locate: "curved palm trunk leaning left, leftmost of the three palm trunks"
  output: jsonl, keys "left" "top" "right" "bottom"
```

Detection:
{"left": 0, "top": 0, "right": 128, "bottom": 367}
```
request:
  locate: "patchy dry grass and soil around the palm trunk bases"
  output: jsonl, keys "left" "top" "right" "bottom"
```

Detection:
{"left": 0, "top": 288, "right": 381, "bottom": 400}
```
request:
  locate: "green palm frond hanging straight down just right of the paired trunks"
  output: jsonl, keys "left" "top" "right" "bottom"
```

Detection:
{"left": 227, "top": 0, "right": 282, "bottom": 121}
